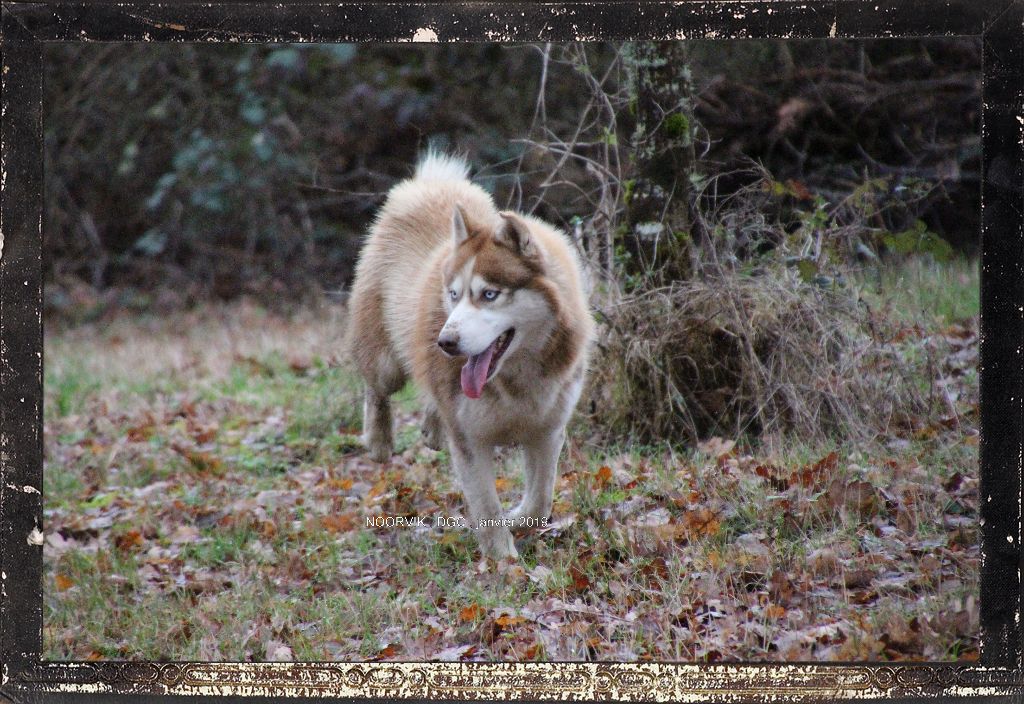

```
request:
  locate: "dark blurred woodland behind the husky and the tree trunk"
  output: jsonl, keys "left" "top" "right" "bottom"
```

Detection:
{"left": 45, "top": 39, "right": 980, "bottom": 315}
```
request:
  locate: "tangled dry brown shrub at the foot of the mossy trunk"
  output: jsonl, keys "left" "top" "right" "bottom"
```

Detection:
{"left": 582, "top": 269, "right": 931, "bottom": 442}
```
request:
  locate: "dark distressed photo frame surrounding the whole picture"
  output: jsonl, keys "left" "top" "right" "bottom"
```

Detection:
{"left": 0, "top": 0, "right": 1024, "bottom": 702}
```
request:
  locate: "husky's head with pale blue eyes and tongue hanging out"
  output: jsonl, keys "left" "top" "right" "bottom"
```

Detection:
{"left": 437, "top": 206, "right": 553, "bottom": 398}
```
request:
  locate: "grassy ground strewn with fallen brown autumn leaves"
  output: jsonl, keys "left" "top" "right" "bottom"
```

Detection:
{"left": 44, "top": 261, "right": 980, "bottom": 661}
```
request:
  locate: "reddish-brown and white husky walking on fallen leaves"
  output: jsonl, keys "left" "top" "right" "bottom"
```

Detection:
{"left": 348, "top": 151, "right": 593, "bottom": 559}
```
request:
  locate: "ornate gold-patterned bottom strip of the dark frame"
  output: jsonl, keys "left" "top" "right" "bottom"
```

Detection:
{"left": 9, "top": 662, "right": 1024, "bottom": 702}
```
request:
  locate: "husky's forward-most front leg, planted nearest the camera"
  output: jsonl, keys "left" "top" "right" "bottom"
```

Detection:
{"left": 452, "top": 442, "right": 519, "bottom": 560}
